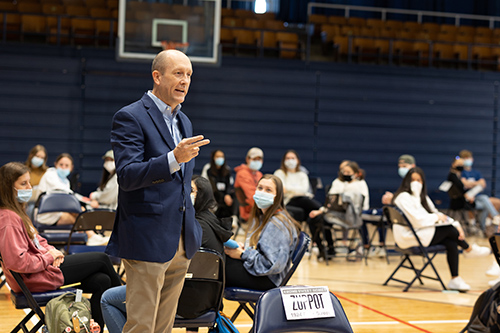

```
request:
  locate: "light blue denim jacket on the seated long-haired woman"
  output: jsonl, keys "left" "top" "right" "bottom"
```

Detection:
{"left": 241, "top": 216, "right": 297, "bottom": 286}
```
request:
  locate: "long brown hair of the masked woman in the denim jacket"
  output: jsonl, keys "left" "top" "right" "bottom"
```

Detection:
{"left": 247, "top": 174, "right": 300, "bottom": 246}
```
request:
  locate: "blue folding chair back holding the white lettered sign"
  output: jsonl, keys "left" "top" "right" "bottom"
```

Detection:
{"left": 254, "top": 287, "right": 352, "bottom": 333}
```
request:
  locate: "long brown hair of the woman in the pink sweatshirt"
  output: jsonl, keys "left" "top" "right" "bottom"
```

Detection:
{"left": 0, "top": 162, "right": 37, "bottom": 239}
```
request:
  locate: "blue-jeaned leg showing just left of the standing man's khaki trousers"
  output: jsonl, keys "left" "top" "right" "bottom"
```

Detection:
{"left": 101, "top": 286, "right": 127, "bottom": 333}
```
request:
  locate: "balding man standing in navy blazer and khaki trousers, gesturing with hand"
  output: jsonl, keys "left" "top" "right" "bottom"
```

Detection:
{"left": 106, "top": 50, "right": 209, "bottom": 333}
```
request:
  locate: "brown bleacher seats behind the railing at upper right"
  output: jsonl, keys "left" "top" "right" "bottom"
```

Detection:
{"left": 309, "top": 14, "right": 500, "bottom": 70}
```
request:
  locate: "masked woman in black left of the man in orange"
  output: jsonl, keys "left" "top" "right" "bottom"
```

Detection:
{"left": 202, "top": 150, "right": 235, "bottom": 218}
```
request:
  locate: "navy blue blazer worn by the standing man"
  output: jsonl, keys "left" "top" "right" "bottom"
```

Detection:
{"left": 106, "top": 94, "right": 202, "bottom": 262}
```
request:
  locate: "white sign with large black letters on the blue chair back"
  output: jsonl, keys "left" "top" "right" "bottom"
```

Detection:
{"left": 280, "top": 287, "right": 335, "bottom": 320}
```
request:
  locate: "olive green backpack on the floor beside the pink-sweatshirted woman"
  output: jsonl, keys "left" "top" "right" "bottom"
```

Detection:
{"left": 45, "top": 292, "right": 92, "bottom": 333}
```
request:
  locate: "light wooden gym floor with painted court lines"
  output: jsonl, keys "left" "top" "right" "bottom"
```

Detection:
{"left": 0, "top": 228, "right": 493, "bottom": 333}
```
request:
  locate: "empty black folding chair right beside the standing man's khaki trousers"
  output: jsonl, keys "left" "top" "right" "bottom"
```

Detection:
{"left": 174, "top": 248, "right": 225, "bottom": 328}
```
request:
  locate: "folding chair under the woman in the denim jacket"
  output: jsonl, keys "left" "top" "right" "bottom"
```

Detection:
{"left": 224, "top": 232, "right": 311, "bottom": 322}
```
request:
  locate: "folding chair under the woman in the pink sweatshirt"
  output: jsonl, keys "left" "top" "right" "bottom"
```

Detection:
{"left": 0, "top": 255, "right": 76, "bottom": 333}
